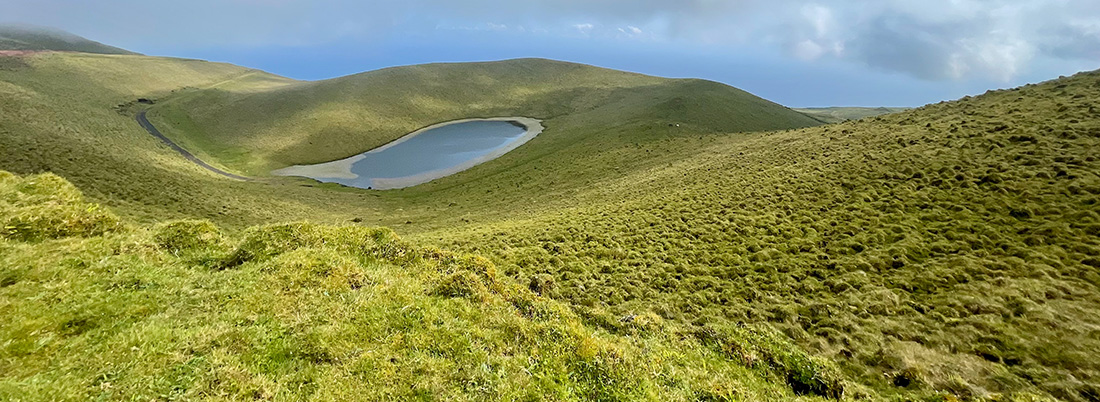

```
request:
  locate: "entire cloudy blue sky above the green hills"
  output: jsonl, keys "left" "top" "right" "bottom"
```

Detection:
{"left": 0, "top": 0, "right": 1100, "bottom": 107}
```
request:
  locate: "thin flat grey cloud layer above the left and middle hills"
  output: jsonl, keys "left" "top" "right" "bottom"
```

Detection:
{"left": 0, "top": 0, "right": 747, "bottom": 46}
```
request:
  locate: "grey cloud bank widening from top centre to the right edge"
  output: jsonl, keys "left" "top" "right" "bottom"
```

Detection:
{"left": 463, "top": 0, "right": 1100, "bottom": 80}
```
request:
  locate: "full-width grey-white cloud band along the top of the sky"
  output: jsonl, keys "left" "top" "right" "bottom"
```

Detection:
{"left": 0, "top": 0, "right": 1100, "bottom": 103}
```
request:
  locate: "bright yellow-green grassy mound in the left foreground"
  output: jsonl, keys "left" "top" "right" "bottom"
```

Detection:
{"left": 0, "top": 172, "right": 849, "bottom": 401}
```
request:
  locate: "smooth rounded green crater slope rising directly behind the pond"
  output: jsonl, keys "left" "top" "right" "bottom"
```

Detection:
{"left": 150, "top": 58, "right": 817, "bottom": 175}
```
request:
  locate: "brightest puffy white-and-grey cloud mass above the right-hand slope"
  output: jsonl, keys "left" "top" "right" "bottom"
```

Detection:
{"left": 762, "top": 0, "right": 1100, "bottom": 82}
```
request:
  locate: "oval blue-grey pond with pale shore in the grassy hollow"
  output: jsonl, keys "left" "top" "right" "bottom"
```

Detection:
{"left": 272, "top": 118, "right": 542, "bottom": 189}
